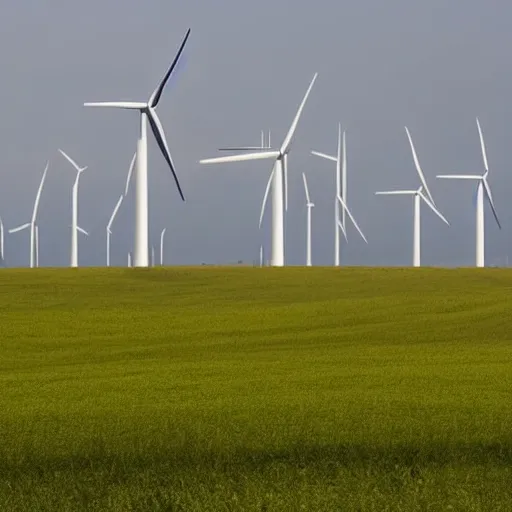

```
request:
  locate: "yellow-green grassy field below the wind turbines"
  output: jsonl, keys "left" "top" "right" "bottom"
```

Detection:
{"left": 0, "top": 268, "right": 512, "bottom": 512}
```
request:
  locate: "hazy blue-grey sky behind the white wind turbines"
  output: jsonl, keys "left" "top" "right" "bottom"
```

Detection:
{"left": 0, "top": 0, "right": 512, "bottom": 266}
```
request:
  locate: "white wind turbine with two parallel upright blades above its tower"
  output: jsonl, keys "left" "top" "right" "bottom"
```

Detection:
{"left": 311, "top": 123, "right": 347, "bottom": 267}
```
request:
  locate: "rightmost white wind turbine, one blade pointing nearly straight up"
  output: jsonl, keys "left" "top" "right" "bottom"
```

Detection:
{"left": 437, "top": 117, "right": 501, "bottom": 267}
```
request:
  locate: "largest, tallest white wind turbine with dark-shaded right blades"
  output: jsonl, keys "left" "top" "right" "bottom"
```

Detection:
{"left": 84, "top": 29, "right": 190, "bottom": 267}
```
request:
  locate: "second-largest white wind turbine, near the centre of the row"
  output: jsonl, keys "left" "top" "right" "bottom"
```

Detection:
{"left": 200, "top": 73, "right": 318, "bottom": 267}
